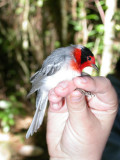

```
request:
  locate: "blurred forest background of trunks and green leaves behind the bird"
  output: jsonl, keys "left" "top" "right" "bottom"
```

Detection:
{"left": 0, "top": 0, "right": 120, "bottom": 160}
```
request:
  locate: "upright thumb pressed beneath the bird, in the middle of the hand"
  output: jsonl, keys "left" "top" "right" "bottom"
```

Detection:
{"left": 66, "top": 90, "right": 91, "bottom": 133}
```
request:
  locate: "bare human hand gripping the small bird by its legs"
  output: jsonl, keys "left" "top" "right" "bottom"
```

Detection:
{"left": 47, "top": 76, "right": 118, "bottom": 160}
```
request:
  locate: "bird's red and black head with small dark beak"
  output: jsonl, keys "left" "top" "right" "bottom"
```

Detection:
{"left": 73, "top": 45, "right": 98, "bottom": 72}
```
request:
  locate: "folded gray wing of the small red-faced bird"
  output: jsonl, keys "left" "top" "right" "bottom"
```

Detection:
{"left": 27, "top": 48, "right": 70, "bottom": 97}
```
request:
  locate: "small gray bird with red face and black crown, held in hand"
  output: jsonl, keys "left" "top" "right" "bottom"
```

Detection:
{"left": 26, "top": 44, "right": 98, "bottom": 139}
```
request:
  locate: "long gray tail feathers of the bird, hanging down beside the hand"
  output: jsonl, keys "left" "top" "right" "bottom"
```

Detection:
{"left": 26, "top": 90, "right": 48, "bottom": 139}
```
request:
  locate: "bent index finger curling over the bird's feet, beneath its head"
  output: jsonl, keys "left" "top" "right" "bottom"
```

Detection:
{"left": 73, "top": 76, "right": 118, "bottom": 109}
